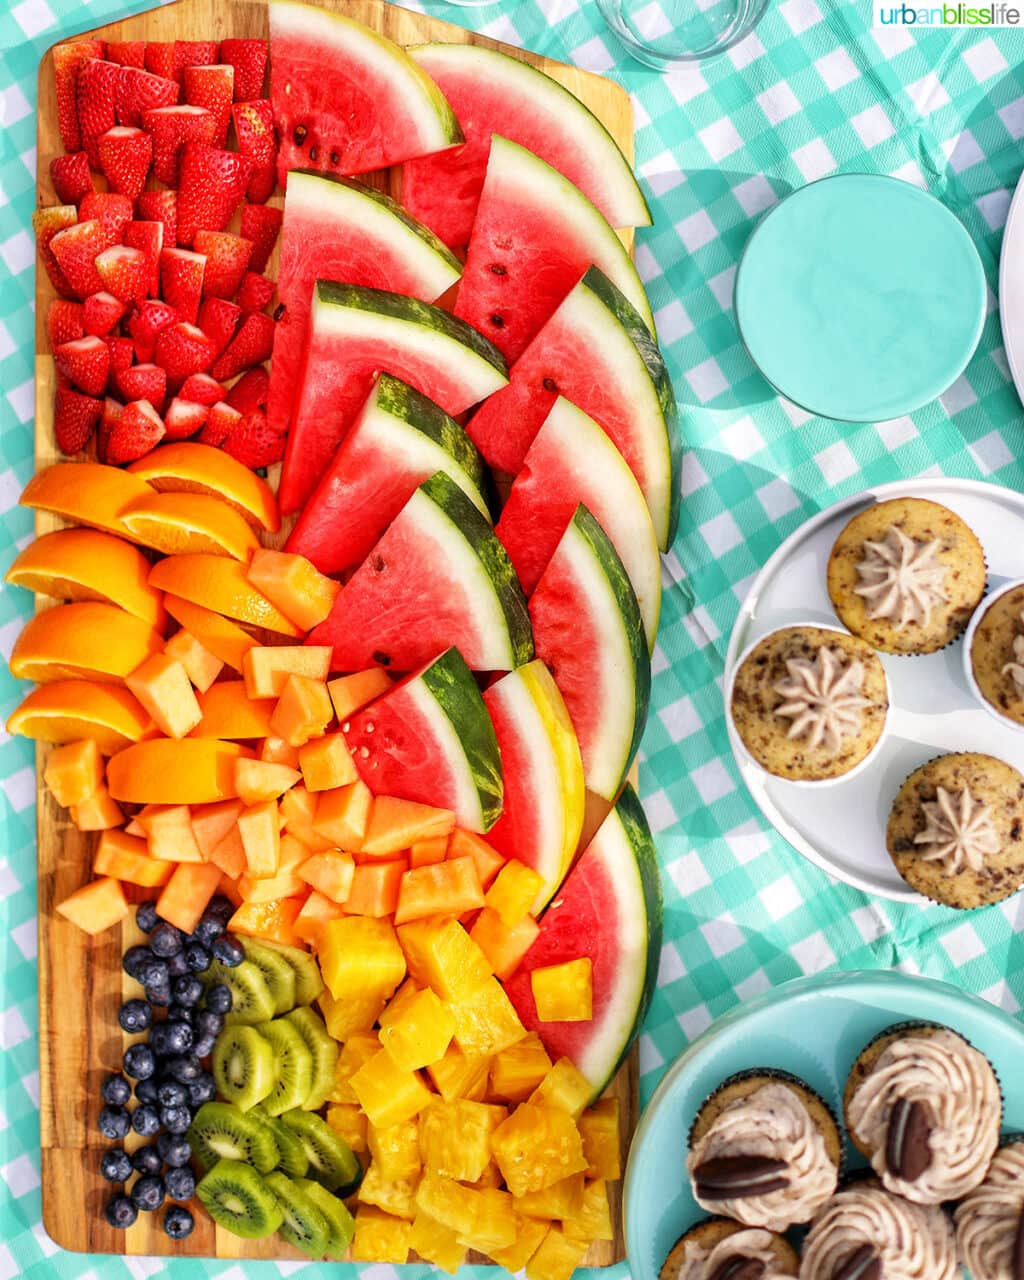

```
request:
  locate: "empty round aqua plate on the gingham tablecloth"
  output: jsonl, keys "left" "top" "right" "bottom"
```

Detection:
{"left": 736, "top": 173, "right": 986, "bottom": 422}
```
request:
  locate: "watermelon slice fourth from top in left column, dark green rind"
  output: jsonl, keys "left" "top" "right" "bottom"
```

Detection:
{"left": 285, "top": 374, "right": 486, "bottom": 573}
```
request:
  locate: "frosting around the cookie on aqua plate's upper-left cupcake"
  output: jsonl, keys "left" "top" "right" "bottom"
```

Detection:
{"left": 686, "top": 1080, "right": 838, "bottom": 1231}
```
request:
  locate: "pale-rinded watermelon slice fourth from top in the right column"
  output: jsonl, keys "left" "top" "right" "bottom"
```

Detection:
{"left": 494, "top": 396, "right": 662, "bottom": 653}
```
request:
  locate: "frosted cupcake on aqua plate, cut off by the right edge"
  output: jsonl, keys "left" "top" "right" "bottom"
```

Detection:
{"left": 954, "top": 1137, "right": 1024, "bottom": 1280}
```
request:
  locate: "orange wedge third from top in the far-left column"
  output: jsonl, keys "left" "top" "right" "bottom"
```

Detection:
{"left": 10, "top": 600, "right": 164, "bottom": 685}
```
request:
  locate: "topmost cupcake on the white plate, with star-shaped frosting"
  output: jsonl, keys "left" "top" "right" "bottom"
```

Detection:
{"left": 828, "top": 498, "right": 986, "bottom": 654}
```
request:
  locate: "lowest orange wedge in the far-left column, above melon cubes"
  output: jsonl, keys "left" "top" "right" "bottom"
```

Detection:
{"left": 8, "top": 680, "right": 152, "bottom": 755}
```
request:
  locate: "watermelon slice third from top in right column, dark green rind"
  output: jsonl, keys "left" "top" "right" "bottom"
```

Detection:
{"left": 467, "top": 268, "right": 681, "bottom": 550}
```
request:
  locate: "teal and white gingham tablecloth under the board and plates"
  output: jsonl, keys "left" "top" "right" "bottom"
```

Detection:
{"left": 0, "top": 0, "right": 1024, "bottom": 1280}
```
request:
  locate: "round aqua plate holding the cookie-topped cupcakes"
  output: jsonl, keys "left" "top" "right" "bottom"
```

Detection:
{"left": 625, "top": 972, "right": 1024, "bottom": 1280}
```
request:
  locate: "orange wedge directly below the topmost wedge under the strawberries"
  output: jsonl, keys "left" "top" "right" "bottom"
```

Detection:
{"left": 120, "top": 492, "right": 260, "bottom": 562}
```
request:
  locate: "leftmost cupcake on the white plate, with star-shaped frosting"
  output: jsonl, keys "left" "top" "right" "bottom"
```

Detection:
{"left": 730, "top": 626, "right": 888, "bottom": 782}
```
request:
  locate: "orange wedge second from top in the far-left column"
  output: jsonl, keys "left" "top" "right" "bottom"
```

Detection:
{"left": 4, "top": 529, "right": 168, "bottom": 631}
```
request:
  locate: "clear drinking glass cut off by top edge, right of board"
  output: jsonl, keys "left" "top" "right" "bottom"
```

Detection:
{"left": 598, "top": 0, "right": 768, "bottom": 70}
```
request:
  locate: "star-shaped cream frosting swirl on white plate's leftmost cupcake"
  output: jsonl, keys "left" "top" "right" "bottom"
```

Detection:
{"left": 772, "top": 646, "right": 868, "bottom": 755}
